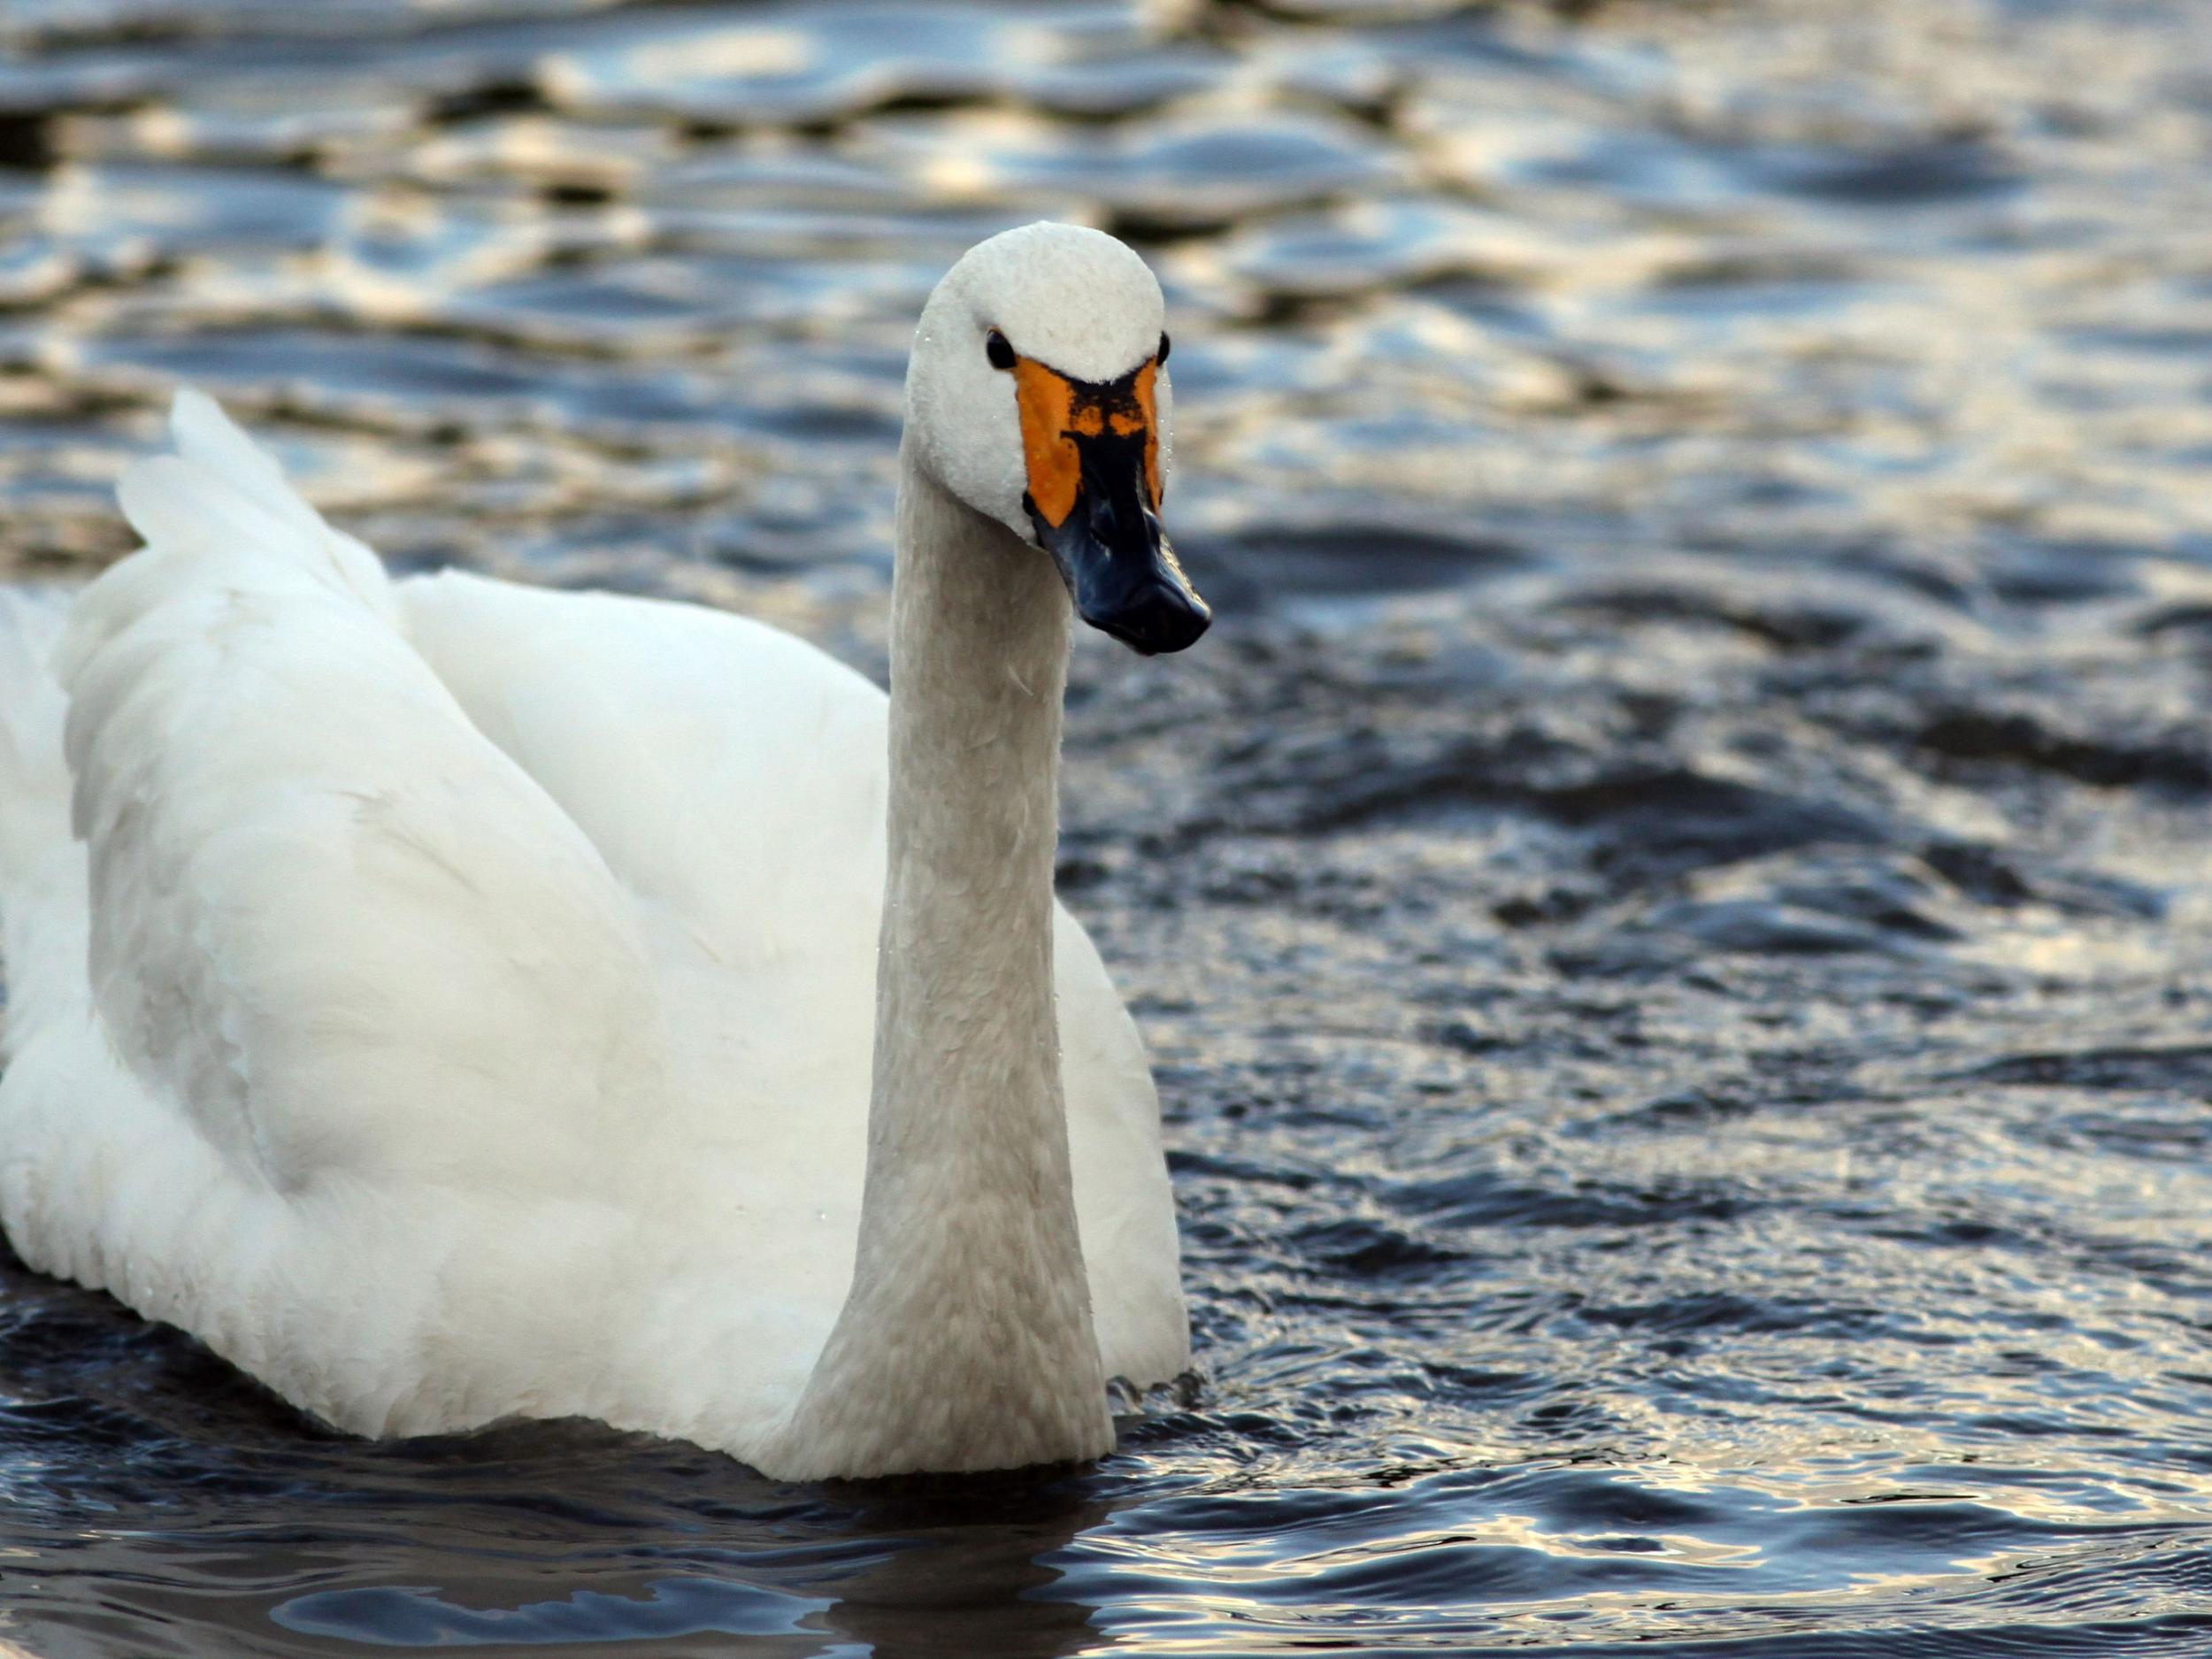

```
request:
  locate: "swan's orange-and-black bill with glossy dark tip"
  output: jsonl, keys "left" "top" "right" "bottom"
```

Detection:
{"left": 1013, "top": 357, "right": 1212, "bottom": 657}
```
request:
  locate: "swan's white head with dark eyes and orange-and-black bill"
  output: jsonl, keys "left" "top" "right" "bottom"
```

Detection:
{"left": 907, "top": 224, "right": 1212, "bottom": 655}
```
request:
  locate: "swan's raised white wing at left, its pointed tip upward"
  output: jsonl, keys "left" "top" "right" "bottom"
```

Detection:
{"left": 60, "top": 396, "right": 659, "bottom": 1190}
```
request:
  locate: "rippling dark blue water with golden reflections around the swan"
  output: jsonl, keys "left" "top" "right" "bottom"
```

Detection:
{"left": 0, "top": 0, "right": 2212, "bottom": 1659}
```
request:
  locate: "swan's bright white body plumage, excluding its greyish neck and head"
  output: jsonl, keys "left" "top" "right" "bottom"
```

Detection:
{"left": 0, "top": 228, "right": 1188, "bottom": 1476}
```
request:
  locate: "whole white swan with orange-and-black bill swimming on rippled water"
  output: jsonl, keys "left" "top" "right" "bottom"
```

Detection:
{"left": 0, "top": 224, "right": 1210, "bottom": 1480}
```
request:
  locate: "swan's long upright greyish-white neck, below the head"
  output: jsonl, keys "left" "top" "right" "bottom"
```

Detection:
{"left": 779, "top": 442, "right": 1113, "bottom": 1476}
